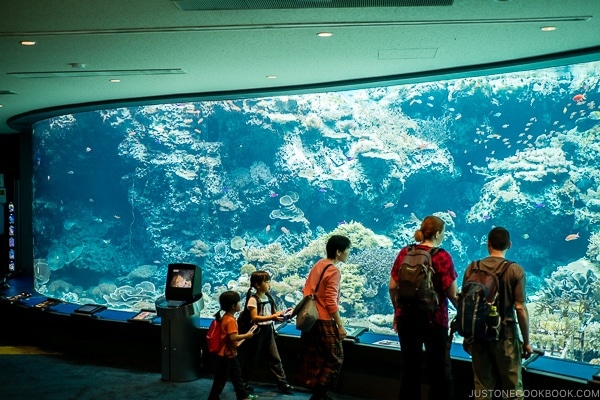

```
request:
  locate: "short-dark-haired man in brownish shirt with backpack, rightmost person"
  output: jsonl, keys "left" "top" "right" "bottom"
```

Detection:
{"left": 457, "top": 227, "right": 532, "bottom": 400}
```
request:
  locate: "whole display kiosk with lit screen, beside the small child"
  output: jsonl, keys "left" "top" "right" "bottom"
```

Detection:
{"left": 155, "top": 264, "right": 204, "bottom": 382}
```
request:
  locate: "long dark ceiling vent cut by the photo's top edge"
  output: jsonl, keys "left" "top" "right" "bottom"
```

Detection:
{"left": 172, "top": 0, "right": 454, "bottom": 11}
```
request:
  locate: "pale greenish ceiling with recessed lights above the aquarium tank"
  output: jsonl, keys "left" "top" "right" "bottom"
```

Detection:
{"left": 0, "top": 0, "right": 600, "bottom": 133}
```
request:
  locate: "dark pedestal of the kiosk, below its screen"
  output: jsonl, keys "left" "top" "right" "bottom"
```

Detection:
{"left": 155, "top": 297, "right": 204, "bottom": 382}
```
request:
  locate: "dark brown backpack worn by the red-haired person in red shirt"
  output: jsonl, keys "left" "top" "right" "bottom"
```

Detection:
{"left": 396, "top": 244, "right": 439, "bottom": 312}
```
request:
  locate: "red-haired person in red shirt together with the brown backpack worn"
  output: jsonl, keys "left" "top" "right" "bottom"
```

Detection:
{"left": 389, "top": 215, "right": 457, "bottom": 400}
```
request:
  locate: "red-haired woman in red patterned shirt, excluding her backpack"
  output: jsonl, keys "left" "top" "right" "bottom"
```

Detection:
{"left": 389, "top": 215, "right": 458, "bottom": 400}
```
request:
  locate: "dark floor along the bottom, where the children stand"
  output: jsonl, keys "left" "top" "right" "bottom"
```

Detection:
{"left": 0, "top": 345, "right": 372, "bottom": 400}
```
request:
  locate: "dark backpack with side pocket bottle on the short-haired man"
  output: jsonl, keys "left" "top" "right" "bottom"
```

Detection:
{"left": 456, "top": 260, "right": 512, "bottom": 342}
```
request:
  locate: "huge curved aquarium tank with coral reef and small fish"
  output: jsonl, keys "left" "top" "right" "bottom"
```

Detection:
{"left": 32, "top": 58, "right": 600, "bottom": 362}
